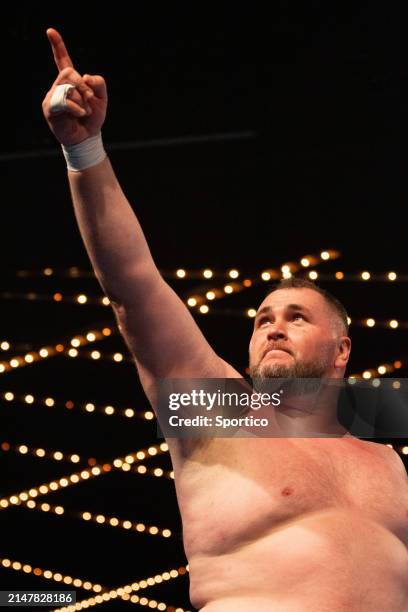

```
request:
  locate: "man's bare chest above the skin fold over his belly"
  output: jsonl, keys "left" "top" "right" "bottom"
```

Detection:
{"left": 178, "top": 438, "right": 408, "bottom": 548}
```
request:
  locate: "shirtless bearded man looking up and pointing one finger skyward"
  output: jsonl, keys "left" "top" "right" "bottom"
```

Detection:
{"left": 43, "top": 29, "right": 408, "bottom": 612}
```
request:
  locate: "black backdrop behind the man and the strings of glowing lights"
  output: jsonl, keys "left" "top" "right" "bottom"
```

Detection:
{"left": 0, "top": 2, "right": 408, "bottom": 610}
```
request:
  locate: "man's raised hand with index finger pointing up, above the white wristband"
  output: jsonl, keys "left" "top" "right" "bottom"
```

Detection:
{"left": 42, "top": 28, "right": 108, "bottom": 145}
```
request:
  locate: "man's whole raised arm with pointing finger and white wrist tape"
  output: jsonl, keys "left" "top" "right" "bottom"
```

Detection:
{"left": 43, "top": 29, "right": 239, "bottom": 399}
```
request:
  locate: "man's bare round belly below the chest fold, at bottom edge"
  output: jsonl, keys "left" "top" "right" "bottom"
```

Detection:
{"left": 189, "top": 508, "right": 408, "bottom": 612}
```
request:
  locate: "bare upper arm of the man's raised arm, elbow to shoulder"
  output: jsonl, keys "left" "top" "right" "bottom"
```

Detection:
{"left": 114, "top": 277, "right": 228, "bottom": 379}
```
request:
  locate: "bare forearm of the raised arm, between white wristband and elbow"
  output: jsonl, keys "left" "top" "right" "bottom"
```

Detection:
{"left": 68, "top": 158, "right": 159, "bottom": 304}
